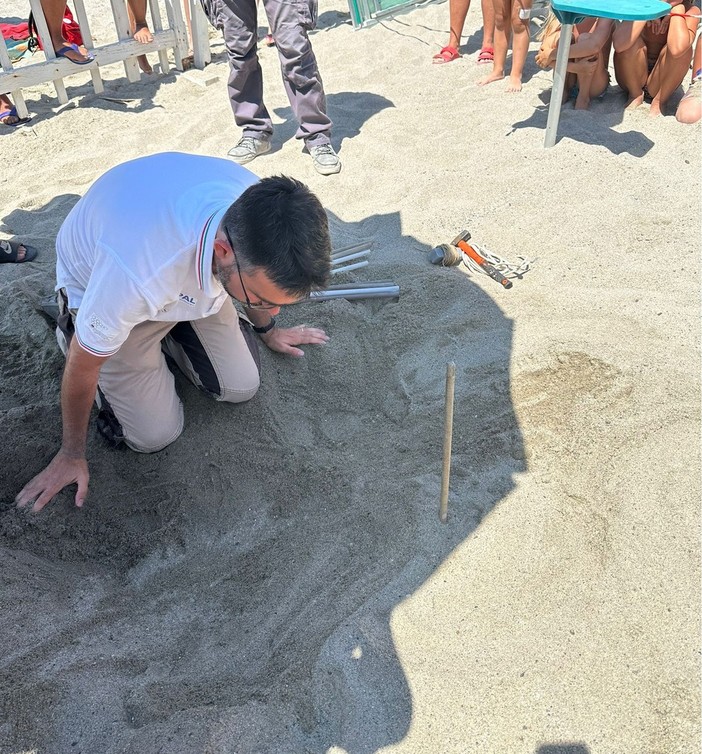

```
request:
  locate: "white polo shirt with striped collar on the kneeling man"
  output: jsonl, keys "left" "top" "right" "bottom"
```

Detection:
{"left": 56, "top": 152, "right": 258, "bottom": 356}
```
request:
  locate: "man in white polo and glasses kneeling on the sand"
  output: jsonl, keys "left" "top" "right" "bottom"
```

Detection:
{"left": 17, "top": 153, "right": 331, "bottom": 511}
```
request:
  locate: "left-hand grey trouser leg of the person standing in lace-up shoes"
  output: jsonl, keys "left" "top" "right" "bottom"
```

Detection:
{"left": 202, "top": 0, "right": 273, "bottom": 138}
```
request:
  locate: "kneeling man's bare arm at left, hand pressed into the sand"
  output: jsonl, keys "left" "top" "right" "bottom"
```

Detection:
{"left": 15, "top": 338, "right": 105, "bottom": 512}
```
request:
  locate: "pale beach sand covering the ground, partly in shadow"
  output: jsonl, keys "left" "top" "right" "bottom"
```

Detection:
{"left": 0, "top": 0, "right": 700, "bottom": 754}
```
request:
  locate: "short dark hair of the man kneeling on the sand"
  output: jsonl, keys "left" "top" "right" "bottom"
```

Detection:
{"left": 222, "top": 175, "right": 331, "bottom": 296}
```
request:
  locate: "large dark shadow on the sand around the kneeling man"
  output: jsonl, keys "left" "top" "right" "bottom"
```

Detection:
{"left": 0, "top": 197, "right": 528, "bottom": 754}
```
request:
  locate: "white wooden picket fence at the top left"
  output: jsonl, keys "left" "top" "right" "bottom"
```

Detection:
{"left": 0, "top": 0, "right": 210, "bottom": 118}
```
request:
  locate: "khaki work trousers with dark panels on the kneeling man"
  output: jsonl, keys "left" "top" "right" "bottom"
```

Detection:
{"left": 57, "top": 291, "right": 260, "bottom": 453}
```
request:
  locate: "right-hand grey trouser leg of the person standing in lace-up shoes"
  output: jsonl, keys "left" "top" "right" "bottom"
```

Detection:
{"left": 263, "top": 0, "right": 332, "bottom": 147}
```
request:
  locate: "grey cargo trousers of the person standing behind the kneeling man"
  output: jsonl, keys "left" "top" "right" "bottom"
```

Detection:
{"left": 202, "top": 0, "right": 332, "bottom": 146}
